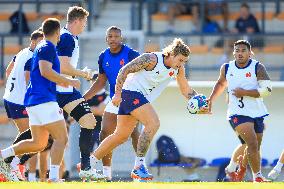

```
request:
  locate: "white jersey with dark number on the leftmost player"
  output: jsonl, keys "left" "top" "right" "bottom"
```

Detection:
{"left": 3, "top": 48, "right": 33, "bottom": 105}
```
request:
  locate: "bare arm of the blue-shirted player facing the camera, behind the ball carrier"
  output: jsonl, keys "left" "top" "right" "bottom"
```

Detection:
{"left": 84, "top": 73, "right": 107, "bottom": 100}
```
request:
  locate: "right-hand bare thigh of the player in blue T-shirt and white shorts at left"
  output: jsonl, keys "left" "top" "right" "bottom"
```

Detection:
{"left": 44, "top": 119, "right": 67, "bottom": 143}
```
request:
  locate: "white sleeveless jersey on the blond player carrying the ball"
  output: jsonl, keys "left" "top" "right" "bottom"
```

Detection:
{"left": 122, "top": 52, "right": 178, "bottom": 102}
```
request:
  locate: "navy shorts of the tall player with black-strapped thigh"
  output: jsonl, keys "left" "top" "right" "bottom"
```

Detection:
{"left": 56, "top": 89, "right": 83, "bottom": 108}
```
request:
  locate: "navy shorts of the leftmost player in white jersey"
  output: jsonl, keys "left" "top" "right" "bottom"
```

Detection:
{"left": 4, "top": 100, "right": 29, "bottom": 119}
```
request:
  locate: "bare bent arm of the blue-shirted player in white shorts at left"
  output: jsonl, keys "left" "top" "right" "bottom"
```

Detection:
{"left": 39, "top": 60, "right": 80, "bottom": 88}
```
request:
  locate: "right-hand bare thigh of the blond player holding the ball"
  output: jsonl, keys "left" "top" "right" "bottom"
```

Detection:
{"left": 131, "top": 103, "right": 160, "bottom": 128}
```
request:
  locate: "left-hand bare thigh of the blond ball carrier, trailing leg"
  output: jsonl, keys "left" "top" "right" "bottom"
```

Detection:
{"left": 114, "top": 115, "right": 138, "bottom": 139}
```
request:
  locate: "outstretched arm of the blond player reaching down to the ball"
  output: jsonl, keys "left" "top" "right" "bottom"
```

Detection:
{"left": 176, "top": 66, "right": 197, "bottom": 99}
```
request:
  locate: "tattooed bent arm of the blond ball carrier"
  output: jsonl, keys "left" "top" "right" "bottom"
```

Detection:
{"left": 115, "top": 53, "right": 157, "bottom": 97}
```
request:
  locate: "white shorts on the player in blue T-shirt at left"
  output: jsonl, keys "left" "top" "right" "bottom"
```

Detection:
{"left": 26, "top": 102, "right": 64, "bottom": 126}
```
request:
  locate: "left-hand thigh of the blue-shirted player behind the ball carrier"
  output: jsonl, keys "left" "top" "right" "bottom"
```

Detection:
{"left": 101, "top": 112, "right": 117, "bottom": 135}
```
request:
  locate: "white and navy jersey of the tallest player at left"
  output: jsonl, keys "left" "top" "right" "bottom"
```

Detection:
{"left": 56, "top": 28, "right": 80, "bottom": 93}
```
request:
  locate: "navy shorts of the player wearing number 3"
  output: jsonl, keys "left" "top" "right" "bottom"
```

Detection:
{"left": 229, "top": 115, "right": 264, "bottom": 133}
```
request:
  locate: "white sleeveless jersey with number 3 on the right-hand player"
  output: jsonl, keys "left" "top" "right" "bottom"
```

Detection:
{"left": 226, "top": 59, "right": 268, "bottom": 118}
